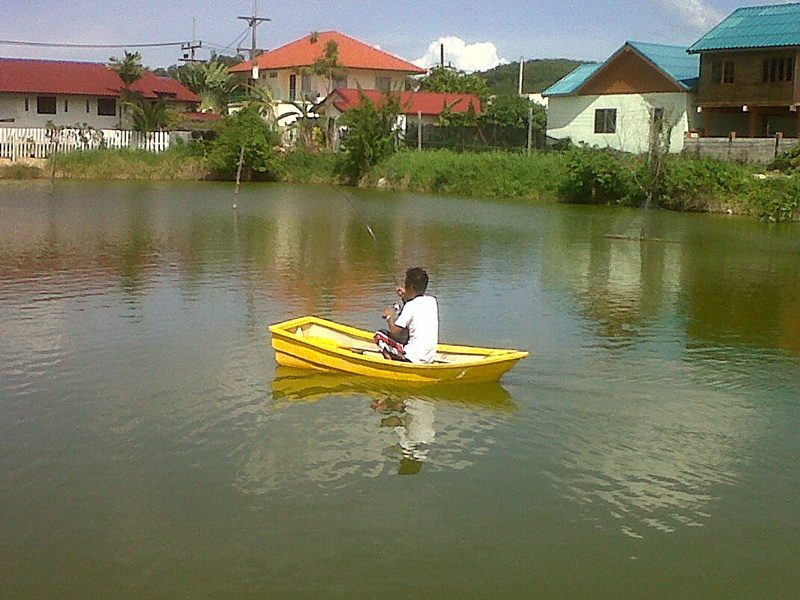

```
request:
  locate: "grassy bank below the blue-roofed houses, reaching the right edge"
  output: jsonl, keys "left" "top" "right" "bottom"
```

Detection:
{"left": 364, "top": 148, "right": 800, "bottom": 221}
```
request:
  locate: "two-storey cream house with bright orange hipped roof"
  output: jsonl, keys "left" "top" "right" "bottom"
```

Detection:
{"left": 231, "top": 31, "right": 426, "bottom": 125}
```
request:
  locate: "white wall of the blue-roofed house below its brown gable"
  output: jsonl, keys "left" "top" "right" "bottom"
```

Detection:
{"left": 547, "top": 92, "right": 698, "bottom": 153}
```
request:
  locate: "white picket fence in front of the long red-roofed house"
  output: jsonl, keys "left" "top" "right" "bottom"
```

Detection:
{"left": 0, "top": 127, "right": 175, "bottom": 161}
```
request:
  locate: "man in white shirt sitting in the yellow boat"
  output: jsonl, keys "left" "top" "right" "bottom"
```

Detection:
{"left": 375, "top": 267, "right": 439, "bottom": 363}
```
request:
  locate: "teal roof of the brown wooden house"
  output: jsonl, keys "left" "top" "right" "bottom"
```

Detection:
{"left": 689, "top": 2, "right": 800, "bottom": 53}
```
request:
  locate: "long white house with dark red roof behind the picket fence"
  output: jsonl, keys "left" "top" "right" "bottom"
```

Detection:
{"left": 0, "top": 58, "right": 200, "bottom": 129}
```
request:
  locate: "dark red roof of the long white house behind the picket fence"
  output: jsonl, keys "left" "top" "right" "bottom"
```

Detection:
{"left": 0, "top": 58, "right": 200, "bottom": 102}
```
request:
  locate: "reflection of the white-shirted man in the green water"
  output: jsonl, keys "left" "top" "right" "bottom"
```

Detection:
{"left": 372, "top": 398, "right": 436, "bottom": 475}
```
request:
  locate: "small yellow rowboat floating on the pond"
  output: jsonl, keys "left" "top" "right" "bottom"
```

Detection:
{"left": 269, "top": 316, "right": 528, "bottom": 383}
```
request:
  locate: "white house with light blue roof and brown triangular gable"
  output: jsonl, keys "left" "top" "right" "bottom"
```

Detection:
{"left": 544, "top": 42, "right": 699, "bottom": 153}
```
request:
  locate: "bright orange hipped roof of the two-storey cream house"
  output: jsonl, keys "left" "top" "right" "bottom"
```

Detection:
{"left": 231, "top": 31, "right": 426, "bottom": 74}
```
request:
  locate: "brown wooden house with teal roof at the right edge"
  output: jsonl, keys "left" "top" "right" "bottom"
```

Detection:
{"left": 688, "top": 3, "right": 800, "bottom": 138}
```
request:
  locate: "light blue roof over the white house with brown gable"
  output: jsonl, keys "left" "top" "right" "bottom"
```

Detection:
{"left": 542, "top": 42, "right": 700, "bottom": 96}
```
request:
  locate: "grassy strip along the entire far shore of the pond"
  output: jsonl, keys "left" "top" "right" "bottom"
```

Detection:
{"left": 0, "top": 146, "right": 800, "bottom": 221}
